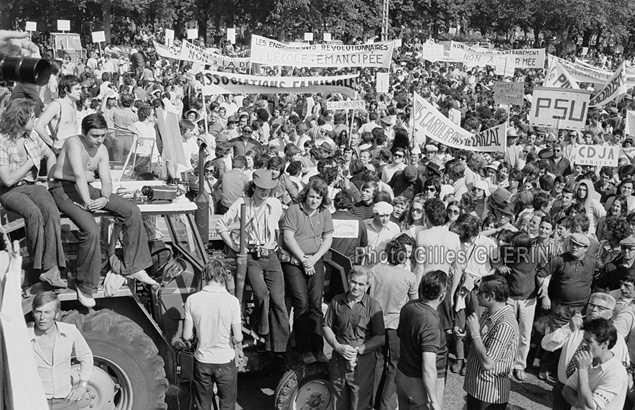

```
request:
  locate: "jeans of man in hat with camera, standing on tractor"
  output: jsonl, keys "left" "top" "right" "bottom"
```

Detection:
{"left": 247, "top": 253, "right": 289, "bottom": 352}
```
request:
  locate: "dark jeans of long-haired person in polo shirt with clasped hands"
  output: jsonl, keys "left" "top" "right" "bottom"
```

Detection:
{"left": 282, "top": 259, "right": 324, "bottom": 353}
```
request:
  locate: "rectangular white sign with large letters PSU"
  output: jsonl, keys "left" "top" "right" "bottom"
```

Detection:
{"left": 529, "top": 87, "right": 591, "bottom": 131}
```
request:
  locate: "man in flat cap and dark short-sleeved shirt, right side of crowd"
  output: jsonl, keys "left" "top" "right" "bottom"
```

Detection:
{"left": 538, "top": 233, "right": 597, "bottom": 327}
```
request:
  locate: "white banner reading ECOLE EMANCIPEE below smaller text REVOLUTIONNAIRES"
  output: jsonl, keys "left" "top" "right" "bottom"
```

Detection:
{"left": 251, "top": 34, "right": 395, "bottom": 68}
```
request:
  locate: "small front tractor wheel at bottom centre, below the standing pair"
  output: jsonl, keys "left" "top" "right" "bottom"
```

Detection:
{"left": 275, "top": 363, "right": 334, "bottom": 410}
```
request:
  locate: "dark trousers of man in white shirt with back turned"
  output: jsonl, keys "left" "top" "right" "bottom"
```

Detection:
{"left": 194, "top": 359, "right": 238, "bottom": 410}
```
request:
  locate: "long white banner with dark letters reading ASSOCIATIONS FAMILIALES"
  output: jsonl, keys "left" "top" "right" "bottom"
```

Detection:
{"left": 203, "top": 71, "right": 358, "bottom": 98}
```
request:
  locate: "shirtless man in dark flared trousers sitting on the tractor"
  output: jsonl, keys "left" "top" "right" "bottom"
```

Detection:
{"left": 49, "top": 114, "right": 158, "bottom": 307}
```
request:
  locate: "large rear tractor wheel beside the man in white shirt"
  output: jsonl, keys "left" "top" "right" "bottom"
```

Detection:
{"left": 62, "top": 309, "right": 169, "bottom": 410}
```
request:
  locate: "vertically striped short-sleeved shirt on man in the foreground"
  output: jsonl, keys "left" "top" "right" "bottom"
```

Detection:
{"left": 463, "top": 305, "right": 519, "bottom": 403}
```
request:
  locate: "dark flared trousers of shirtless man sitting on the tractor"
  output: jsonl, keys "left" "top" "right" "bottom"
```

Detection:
{"left": 49, "top": 181, "right": 152, "bottom": 294}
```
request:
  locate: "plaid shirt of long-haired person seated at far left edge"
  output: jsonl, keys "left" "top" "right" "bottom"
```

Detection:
{"left": 0, "top": 131, "right": 46, "bottom": 186}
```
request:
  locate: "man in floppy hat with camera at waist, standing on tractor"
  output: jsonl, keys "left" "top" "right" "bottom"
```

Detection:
{"left": 216, "top": 169, "right": 289, "bottom": 352}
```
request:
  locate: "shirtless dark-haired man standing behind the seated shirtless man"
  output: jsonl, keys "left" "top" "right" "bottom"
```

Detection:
{"left": 35, "top": 75, "right": 82, "bottom": 154}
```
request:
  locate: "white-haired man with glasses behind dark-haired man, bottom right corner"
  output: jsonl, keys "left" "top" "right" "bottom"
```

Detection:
{"left": 540, "top": 292, "right": 630, "bottom": 410}
